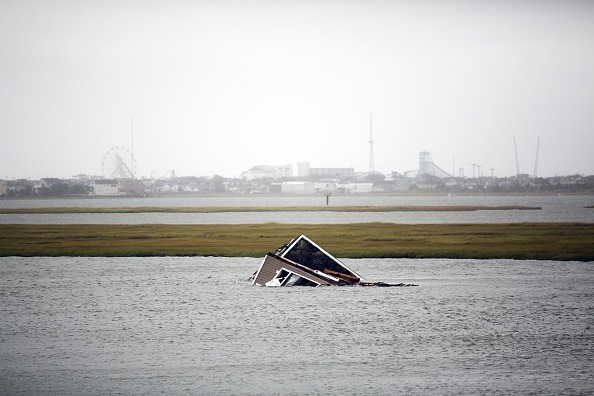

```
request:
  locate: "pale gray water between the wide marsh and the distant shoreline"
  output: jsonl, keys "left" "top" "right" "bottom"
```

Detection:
{"left": 0, "top": 195, "right": 594, "bottom": 224}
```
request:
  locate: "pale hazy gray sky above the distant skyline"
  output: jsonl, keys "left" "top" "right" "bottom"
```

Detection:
{"left": 0, "top": 0, "right": 594, "bottom": 179}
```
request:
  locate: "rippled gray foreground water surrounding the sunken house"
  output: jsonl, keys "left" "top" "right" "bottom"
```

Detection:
{"left": 0, "top": 257, "right": 594, "bottom": 395}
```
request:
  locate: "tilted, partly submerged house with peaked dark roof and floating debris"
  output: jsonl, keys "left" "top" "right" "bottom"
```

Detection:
{"left": 250, "top": 234, "right": 417, "bottom": 287}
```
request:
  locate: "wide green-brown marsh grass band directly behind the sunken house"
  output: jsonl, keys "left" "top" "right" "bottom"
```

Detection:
{"left": 0, "top": 223, "right": 594, "bottom": 261}
